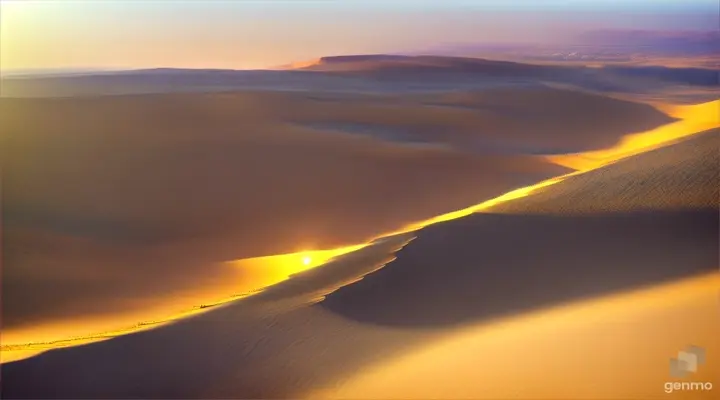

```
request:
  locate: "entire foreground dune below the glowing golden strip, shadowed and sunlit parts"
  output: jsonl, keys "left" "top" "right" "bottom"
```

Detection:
{"left": 2, "top": 111, "right": 720, "bottom": 398}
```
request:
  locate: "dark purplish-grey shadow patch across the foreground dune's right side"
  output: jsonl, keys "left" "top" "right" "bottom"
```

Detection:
{"left": 319, "top": 209, "right": 718, "bottom": 327}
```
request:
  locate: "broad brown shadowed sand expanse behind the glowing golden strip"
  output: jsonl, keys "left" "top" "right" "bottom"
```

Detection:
{"left": 0, "top": 85, "right": 673, "bottom": 344}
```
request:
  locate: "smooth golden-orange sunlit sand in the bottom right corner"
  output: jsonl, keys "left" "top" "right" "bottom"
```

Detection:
{"left": 316, "top": 273, "right": 720, "bottom": 400}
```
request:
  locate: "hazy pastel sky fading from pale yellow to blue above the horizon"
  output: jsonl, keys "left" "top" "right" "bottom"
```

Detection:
{"left": 0, "top": 0, "right": 718, "bottom": 70}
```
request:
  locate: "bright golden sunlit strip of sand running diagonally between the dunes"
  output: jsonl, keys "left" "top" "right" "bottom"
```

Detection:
{"left": 0, "top": 101, "right": 720, "bottom": 362}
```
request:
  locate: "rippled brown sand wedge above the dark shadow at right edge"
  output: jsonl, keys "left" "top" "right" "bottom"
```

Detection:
{"left": 494, "top": 129, "right": 720, "bottom": 214}
